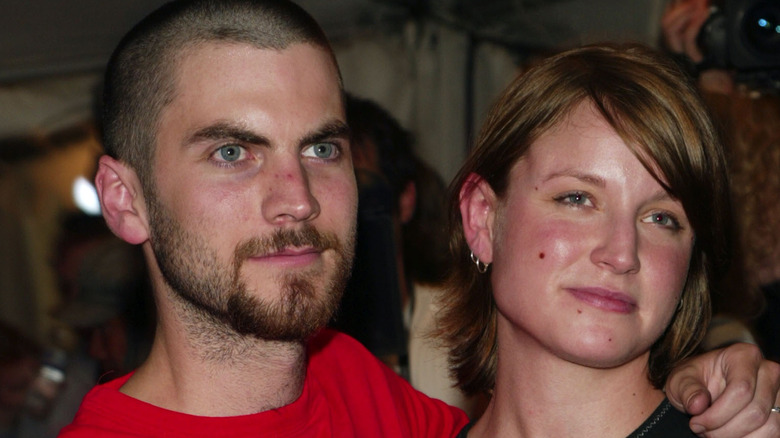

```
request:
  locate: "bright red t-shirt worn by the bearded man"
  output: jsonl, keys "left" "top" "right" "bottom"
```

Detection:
{"left": 60, "top": 330, "right": 468, "bottom": 438}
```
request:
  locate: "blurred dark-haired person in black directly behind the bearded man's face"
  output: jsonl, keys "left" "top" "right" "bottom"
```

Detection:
{"left": 331, "top": 94, "right": 414, "bottom": 370}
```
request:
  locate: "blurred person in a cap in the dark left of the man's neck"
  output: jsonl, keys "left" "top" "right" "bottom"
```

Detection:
{"left": 15, "top": 213, "right": 154, "bottom": 438}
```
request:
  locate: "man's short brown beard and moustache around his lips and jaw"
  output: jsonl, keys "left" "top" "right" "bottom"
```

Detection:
{"left": 149, "top": 197, "right": 355, "bottom": 341}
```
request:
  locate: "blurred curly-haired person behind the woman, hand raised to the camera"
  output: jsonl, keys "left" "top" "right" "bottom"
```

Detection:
{"left": 661, "top": 0, "right": 780, "bottom": 354}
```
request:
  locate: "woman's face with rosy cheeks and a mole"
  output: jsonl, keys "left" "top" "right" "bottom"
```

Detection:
{"left": 483, "top": 104, "right": 694, "bottom": 368}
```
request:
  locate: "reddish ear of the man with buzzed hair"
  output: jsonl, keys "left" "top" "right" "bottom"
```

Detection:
{"left": 95, "top": 155, "right": 149, "bottom": 244}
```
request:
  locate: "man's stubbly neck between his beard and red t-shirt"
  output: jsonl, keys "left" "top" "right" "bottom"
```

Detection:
{"left": 121, "top": 292, "right": 306, "bottom": 417}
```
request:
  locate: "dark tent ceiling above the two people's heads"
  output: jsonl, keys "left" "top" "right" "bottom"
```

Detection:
{"left": 0, "top": 0, "right": 663, "bottom": 84}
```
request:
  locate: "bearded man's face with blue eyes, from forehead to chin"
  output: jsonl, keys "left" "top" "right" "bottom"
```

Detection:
{"left": 147, "top": 43, "right": 357, "bottom": 340}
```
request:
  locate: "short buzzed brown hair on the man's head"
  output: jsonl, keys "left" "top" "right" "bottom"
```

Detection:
{"left": 101, "top": 0, "right": 341, "bottom": 195}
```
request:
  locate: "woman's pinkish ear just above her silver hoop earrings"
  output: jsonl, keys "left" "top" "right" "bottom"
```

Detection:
{"left": 459, "top": 173, "right": 497, "bottom": 263}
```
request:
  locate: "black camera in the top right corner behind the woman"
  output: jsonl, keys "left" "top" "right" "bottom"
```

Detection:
{"left": 697, "top": 0, "right": 780, "bottom": 91}
